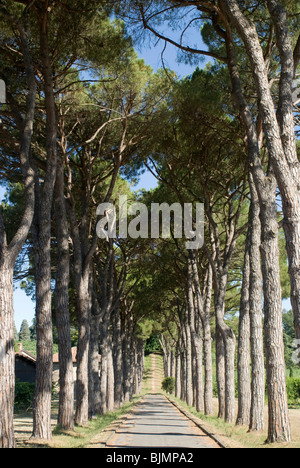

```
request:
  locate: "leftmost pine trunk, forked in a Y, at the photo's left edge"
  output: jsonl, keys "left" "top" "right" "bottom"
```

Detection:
{"left": 0, "top": 20, "right": 36, "bottom": 448}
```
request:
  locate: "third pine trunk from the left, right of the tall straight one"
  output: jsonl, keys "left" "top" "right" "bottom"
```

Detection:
{"left": 55, "top": 160, "right": 74, "bottom": 430}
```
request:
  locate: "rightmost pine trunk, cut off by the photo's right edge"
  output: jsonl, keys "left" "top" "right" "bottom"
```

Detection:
{"left": 267, "top": 4, "right": 300, "bottom": 339}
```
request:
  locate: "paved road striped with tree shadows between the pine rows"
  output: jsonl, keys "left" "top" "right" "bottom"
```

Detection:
{"left": 108, "top": 395, "right": 219, "bottom": 448}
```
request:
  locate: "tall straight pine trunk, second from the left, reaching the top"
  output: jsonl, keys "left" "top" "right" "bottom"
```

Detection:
{"left": 32, "top": 10, "right": 57, "bottom": 440}
